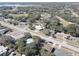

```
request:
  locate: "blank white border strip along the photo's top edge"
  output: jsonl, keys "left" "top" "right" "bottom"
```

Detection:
{"left": 0, "top": 0, "right": 79, "bottom": 2}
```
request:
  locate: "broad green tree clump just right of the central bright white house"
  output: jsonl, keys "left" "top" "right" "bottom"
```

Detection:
{"left": 45, "top": 19, "right": 63, "bottom": 32}
